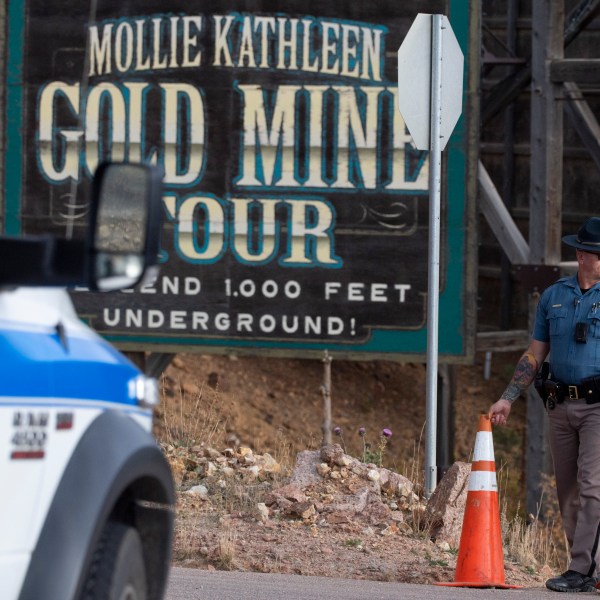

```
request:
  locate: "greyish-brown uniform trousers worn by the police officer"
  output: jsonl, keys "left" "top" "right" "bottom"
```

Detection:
{"left": 547, "top": 398, "right": 600, "bottom": 577}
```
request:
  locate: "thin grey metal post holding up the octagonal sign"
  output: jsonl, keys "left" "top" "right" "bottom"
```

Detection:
{"left": 425, "top": 15, "right": 443, "bottom": 498}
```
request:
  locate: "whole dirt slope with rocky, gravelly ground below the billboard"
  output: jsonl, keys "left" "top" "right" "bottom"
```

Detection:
{"left": 156, "top": 354, "right": 550, "bottom": 587}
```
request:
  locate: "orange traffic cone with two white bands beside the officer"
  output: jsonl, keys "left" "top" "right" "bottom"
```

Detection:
{"left": 436, "top": 415, "right": 519, "bottom": 588}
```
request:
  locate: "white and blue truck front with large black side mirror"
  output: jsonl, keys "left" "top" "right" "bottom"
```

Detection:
{"left": 0, "top": 164, "right": 174, "bottom": 600}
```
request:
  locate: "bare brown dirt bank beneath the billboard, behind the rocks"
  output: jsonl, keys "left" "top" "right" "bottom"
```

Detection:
{"left": 154, "top": 353, "right": 524, "bottom": 476}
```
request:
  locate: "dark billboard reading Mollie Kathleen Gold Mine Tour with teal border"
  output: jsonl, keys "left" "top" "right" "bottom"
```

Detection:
{"left": 4, "top": 0, "right": 470, "bottom": 359}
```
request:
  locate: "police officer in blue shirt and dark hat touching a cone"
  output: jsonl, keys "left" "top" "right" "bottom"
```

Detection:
{"left": 488, "top": 217, "right": 600, "bottom": 592}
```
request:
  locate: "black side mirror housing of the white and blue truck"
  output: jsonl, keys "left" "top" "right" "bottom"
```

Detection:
{"left": 89, "top": 163, "right": 163, "bottom": 292}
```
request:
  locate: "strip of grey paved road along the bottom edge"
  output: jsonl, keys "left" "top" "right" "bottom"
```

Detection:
{"left": 166, "top": 568, "right": 560, "bottom": 600}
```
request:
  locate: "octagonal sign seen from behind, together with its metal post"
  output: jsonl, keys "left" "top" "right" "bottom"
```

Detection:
{"left": 398, "top": 13, "right": 464, "bottom": 498}
